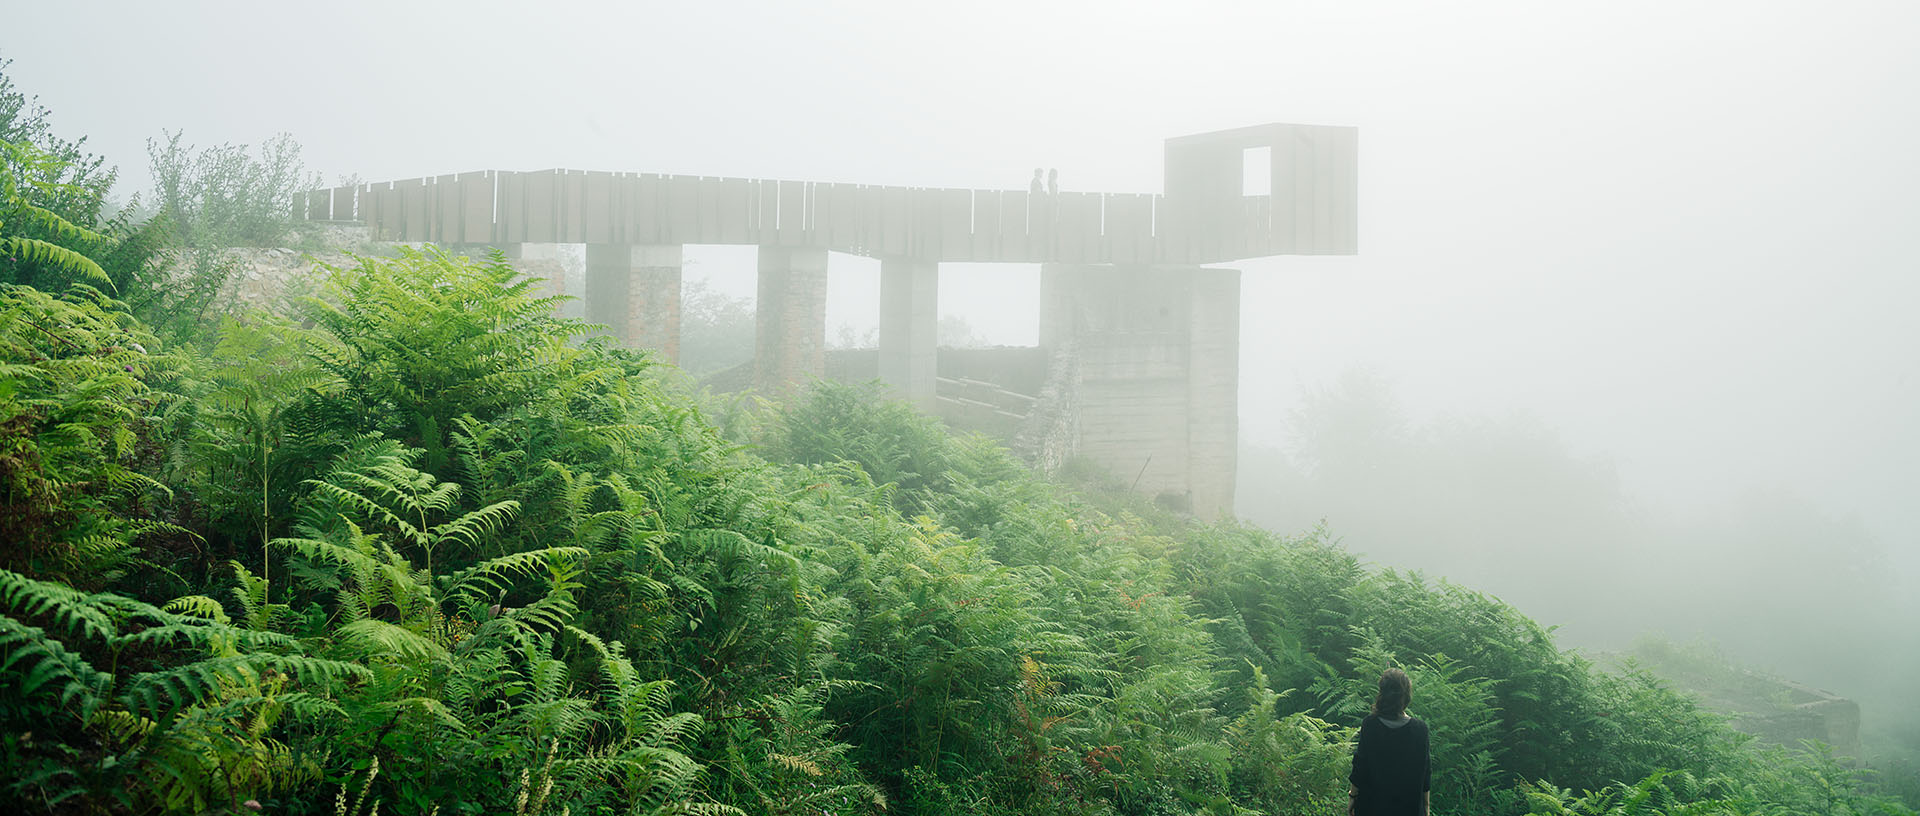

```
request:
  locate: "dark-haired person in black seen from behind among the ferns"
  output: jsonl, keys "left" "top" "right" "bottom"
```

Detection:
{"left": 1346, "top": 668, "right": 1432, "bottom": 816}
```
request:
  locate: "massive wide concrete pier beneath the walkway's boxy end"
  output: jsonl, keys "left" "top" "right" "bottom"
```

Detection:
{"left": 1041, "top": 263, "right": 1240, "bottom": 518}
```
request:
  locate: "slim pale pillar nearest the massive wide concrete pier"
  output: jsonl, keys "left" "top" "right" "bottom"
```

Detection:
{"left": 879, "top": 257, "right": 941, "bottom": 411}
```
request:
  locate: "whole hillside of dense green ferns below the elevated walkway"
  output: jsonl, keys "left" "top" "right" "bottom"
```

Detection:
{"left": 0, "top": 252, "right": 1907, "bottom": 816}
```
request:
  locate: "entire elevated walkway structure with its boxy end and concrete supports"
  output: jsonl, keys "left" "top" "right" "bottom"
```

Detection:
{"left": 294, "top": 125, "right": 1359, "bottom": 516}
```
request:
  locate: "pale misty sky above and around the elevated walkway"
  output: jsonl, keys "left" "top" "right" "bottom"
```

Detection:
{"left": 0, "top": 0, "right": 1920, "bottom": 568}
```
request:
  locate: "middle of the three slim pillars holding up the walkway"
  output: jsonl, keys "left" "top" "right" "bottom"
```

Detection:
{"left": 753, "top": 246, "right": 828, "bottom": 394}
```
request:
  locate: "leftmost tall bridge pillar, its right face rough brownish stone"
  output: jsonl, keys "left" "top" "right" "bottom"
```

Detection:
{"left": 584, "top": 244, "right": 682, "bottom": 361}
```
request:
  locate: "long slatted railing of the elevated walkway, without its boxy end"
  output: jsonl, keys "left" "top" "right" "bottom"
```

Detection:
{"left": 294, "top": 171, "right": 1336, "bottom": 263}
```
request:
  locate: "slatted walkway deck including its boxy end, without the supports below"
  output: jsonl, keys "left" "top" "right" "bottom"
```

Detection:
{"left": 296, "top": 125, "right": 1357, "bottom": 265}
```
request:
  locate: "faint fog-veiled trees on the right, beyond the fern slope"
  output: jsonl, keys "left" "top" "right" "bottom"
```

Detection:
{"left": 1240, "top": 372, "right": 1920, "bottom": 775}
